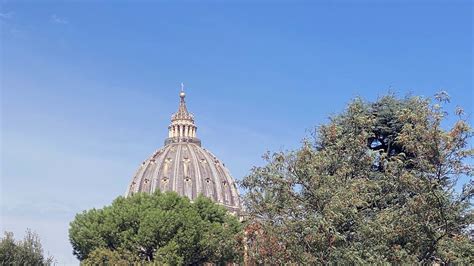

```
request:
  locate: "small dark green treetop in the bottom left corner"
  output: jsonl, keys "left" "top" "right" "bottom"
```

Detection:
{"left": 0, "top": 230, "right": 53, "bottom": 265}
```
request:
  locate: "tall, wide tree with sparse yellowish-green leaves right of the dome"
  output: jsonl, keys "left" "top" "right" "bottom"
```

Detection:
{"left": 241, "top": 93, "right": 474, "bottom": 264}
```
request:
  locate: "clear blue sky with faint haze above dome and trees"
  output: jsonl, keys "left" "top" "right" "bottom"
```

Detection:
{"left": 0, "top": 1, "right": 474, "bottom": 264}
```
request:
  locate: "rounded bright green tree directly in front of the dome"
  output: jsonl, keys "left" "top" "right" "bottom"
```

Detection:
{"left": 69, "top": 192, "right": 242, "bottom": 265}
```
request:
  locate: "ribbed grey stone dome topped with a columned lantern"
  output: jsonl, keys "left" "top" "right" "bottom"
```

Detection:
{"left": 126, "top": 85, "right": 240, "bottom": 213}
